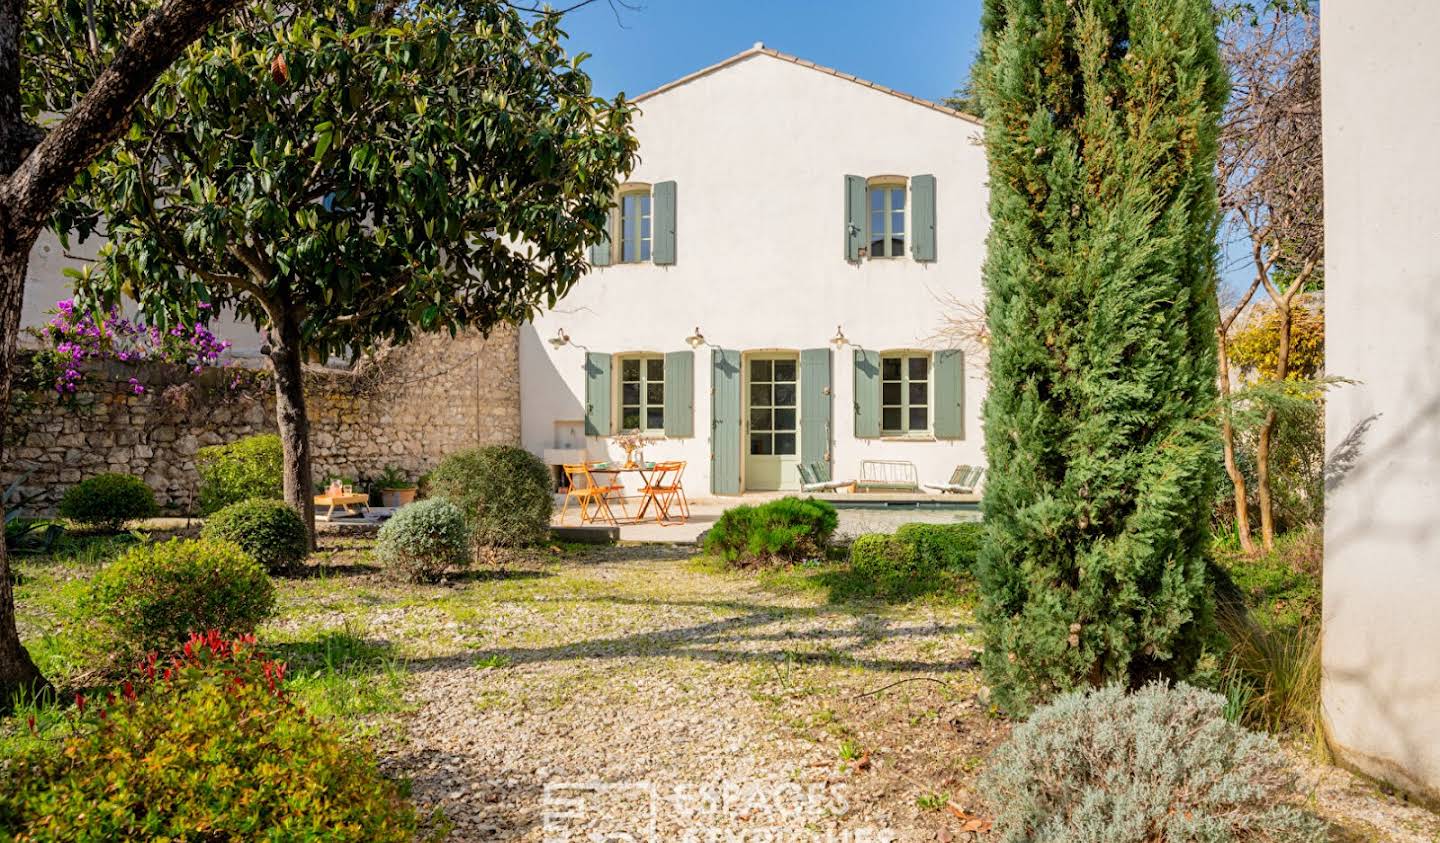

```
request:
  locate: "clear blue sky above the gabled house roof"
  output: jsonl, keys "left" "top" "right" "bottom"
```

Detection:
{"left": 552, "top": 0, "right": 981, "bottom": 99}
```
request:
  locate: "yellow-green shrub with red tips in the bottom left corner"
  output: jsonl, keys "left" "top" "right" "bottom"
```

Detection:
{"left": 0, "top": 633, "right": 416, "bottom": 843}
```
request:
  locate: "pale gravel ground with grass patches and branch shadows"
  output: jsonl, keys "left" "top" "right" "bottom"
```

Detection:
{"left": 347, "top": 552, "right": 1005, "bottom": 840}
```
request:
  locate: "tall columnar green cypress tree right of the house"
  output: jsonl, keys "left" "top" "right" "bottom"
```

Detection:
{"left": 976, "top": 0, "right": 1228, "bottom": 713}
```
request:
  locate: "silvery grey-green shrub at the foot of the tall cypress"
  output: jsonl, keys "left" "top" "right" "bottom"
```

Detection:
{"left": 979, "top": 683, "right": 1325, "bottom": 843}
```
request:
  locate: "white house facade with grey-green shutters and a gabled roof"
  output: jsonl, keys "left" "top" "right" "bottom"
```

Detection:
{"left": 520, "top": 45, "right": 989, "bottom": 496}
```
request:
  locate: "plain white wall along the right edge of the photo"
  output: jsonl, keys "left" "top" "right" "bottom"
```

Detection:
{"left": 1320, "top": 0, "right": 1440, "bottom": 803}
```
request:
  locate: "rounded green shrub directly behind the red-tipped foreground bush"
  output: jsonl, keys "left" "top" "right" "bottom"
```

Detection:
{"left": 82, "top": 539, "right": 275, "bottom": 659}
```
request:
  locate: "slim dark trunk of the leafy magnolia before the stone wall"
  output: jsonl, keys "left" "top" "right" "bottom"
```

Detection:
{"left": 269, "top": 304, "right": 315, "bottom": 550}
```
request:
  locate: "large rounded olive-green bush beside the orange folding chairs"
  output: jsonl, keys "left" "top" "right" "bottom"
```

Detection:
{"left": 428, "top": 445, "right": 554, "bottom": 548}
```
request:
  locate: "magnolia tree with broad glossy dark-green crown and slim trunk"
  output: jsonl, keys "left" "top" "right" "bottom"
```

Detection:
{"left": 59, "top": 0, "right": 636, "bottom": 544}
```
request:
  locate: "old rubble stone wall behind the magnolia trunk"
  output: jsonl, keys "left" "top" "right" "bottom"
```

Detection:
{"left": 0, "top": 329, "right": 520, "bottom": 514}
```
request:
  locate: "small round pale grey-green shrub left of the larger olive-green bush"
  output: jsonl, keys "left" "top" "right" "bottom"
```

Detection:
{"left": 374, "top": 497, "right": 469, "bottom": 582}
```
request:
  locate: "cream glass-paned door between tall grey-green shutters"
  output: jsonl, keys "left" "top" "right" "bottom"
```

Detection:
{"left": 744, "top": 353, "right": 801, "bottom": 491}
